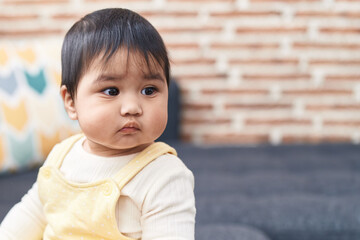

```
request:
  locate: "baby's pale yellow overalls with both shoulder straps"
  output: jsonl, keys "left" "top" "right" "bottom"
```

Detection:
{"left": 37, "top": 135, "right": 176, "bottom": 240}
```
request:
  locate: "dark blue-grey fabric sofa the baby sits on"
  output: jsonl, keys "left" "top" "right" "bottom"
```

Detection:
{"left": 0, "top": 141, "right": 360, "bottom": 240}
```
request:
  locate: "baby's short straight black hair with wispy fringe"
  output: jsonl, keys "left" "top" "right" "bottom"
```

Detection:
{"left": 61, "top": 8, "right": 170, "bottom": 97}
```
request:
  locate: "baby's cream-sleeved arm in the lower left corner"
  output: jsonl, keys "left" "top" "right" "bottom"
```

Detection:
{"left": 0, "top": 183, "right": 46, "bottom": 240}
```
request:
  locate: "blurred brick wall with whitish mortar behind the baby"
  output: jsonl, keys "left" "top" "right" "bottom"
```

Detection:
{"left": 0, "top": 0, "right": 360, "bottom": 144}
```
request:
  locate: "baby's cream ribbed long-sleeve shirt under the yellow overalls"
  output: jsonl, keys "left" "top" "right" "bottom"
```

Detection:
{"left": 0, "top": 138, "right": 196, "bottom": 240}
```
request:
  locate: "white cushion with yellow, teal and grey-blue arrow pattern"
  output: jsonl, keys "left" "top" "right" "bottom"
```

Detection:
{"left": 0, "top": 40, "right": 79, "bottom": 173}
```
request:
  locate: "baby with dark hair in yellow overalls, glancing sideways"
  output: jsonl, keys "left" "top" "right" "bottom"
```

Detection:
{"left": 0, "top": 8, "right": 196, "bottom": 240}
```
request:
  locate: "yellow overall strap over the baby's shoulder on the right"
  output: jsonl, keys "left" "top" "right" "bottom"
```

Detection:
{"left": 114, "top": 142, "right": 177, "bottom": 190}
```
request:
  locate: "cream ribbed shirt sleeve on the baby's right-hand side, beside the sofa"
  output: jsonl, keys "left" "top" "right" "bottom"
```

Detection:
{"left": 141, "top": 156, "right": 196, "bottom": 240}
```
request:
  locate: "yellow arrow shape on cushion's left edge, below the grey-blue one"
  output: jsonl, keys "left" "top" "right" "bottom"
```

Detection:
{"left": 1, "top": 100, "right": 28, "bottom": 132}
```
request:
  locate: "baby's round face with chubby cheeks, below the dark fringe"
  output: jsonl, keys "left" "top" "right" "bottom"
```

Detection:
{"left": 73, "top": 50, "right": 168, "bottom": 156}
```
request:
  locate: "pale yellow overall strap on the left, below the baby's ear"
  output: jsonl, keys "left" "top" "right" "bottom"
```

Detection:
{"left": 46, "top": 133, "right": 84, "bottom": 168}
